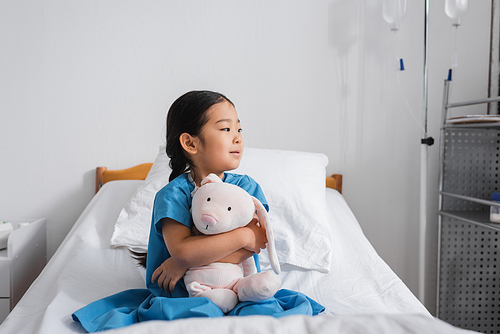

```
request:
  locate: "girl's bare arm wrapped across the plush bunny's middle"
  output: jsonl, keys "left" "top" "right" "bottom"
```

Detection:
{"left": 161, "top": 218, "right": 267, "bottom": 268}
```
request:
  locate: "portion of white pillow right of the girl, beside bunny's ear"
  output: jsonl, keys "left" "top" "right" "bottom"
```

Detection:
{"left": 234, "top": 148, "right": 332, "bottom": 272}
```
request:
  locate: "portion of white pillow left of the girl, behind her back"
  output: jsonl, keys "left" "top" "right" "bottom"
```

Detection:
{"left": 110, "top": 144, "right": 172, "bottom": 251}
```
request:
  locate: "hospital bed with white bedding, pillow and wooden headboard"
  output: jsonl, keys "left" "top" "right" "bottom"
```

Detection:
{"left": 0, "top": 146, "right": 476, "bottom": 334}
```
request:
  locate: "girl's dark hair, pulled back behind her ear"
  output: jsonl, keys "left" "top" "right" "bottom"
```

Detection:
{"left": 166, "top": 90, "right": 234, "bottom": 181}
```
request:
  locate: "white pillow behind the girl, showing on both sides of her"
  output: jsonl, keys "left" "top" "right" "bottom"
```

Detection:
{"left": 111, "top": 145, "right": 332, "bottom": 272}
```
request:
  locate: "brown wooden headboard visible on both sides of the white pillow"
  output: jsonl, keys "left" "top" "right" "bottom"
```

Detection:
{"left": 95, "top": 163, "right": 342, "bottom": 194}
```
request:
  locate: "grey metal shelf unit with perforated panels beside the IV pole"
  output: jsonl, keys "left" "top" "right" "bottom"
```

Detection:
{"left": 436, "top": 80, "right": 500, "bottom": 333}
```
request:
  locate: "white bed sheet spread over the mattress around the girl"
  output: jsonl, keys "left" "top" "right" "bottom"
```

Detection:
{"left": 0, "top": 181, "right": 474, "bottom": 333}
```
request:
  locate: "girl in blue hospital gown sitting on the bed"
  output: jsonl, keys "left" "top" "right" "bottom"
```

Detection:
{"left": 72, "top": 91, "right": 324, "bottom": 332}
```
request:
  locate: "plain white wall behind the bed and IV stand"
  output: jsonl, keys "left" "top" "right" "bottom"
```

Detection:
{"left": 0, "top": 0, "right": 489, "bottom": 310}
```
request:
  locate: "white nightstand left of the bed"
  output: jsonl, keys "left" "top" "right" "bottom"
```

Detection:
{"left": 0, "top": 218, "right": 47, "bottom": 323}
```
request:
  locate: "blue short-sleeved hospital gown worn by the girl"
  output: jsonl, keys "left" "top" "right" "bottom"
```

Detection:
{"left": 72, "top": 173, "right": 324, "bottom": 332}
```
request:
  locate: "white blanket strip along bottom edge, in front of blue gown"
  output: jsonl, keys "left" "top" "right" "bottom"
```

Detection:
{"left": 109, "top": 314, "right": 473, "bottom": 334}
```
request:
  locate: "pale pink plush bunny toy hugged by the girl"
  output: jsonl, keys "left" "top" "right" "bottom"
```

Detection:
{"left": 184, "top": 174, "right": 281, "bottom": 313}
